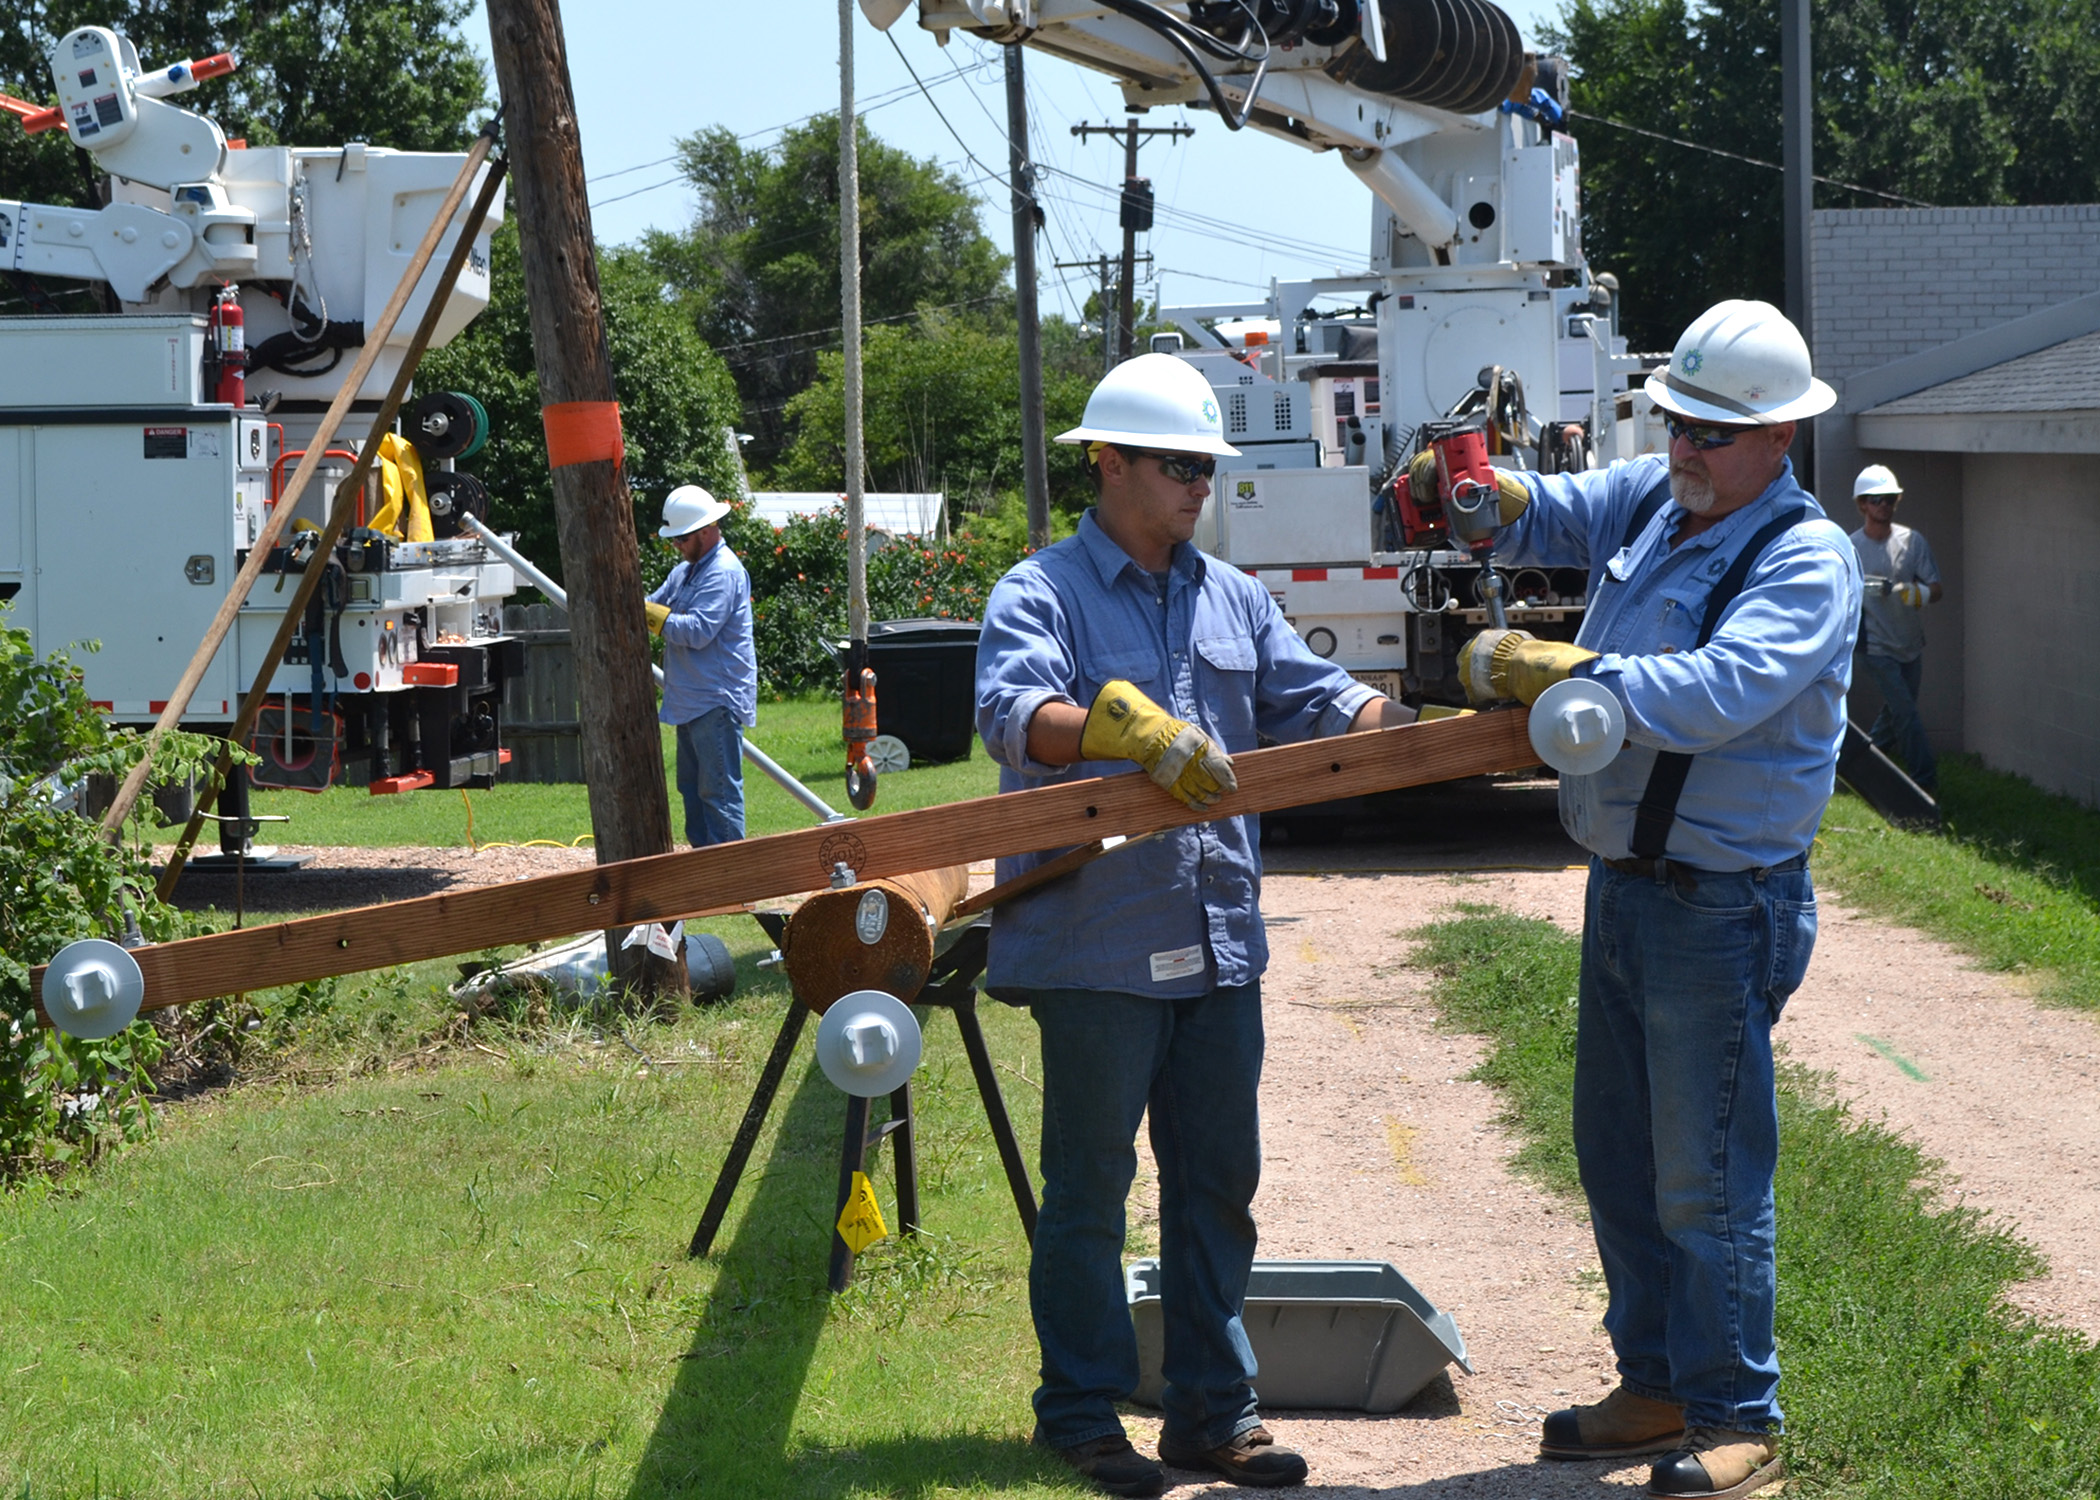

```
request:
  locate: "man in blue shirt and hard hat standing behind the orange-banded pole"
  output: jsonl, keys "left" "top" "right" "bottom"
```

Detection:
{"left": 645, "top": 485, "right": 758, "bottom": 849}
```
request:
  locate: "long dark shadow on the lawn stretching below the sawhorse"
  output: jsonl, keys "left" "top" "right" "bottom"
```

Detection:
{"left": 628, "top": 1046, "right": 1046, "bottom": 1500}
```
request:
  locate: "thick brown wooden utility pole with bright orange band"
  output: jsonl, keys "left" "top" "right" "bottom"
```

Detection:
{"left": 487, "top": 0, "right": 687, "bottom": 996}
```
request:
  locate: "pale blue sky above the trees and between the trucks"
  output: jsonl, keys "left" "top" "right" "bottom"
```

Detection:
{"left": 466, "top": 0, "right": 1558, "bottom": 315}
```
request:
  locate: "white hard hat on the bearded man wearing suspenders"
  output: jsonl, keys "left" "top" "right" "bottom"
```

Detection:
{"left": 1644, "top": 300, "right": 1838, "bottom": 426}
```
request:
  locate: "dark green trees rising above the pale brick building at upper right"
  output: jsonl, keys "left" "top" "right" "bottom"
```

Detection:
{"left": 1548, "top": 0, "right": 2100, "bottom": 349}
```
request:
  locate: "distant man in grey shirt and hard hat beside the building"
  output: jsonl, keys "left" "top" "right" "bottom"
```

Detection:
{"left": 1852, "top": 464, "right": 1947, "bottom": 792}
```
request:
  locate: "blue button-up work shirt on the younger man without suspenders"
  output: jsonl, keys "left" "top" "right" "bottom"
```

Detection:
{"left": 977, "top": 511, "right": 1378, "bottom": 998}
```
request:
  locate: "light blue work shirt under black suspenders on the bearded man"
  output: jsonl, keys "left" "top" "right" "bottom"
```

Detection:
{"left": 1495, "top": 456, "right": 1861, "bottom": 870}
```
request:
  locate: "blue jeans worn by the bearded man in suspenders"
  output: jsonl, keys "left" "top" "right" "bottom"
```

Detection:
{"left": 1575, "top": 859, "right": 1817, "bottom": 1431}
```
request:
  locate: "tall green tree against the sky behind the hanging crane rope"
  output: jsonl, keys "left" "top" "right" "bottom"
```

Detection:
{"left": 645, "top": 116, "right": 1012, "bottom": 464}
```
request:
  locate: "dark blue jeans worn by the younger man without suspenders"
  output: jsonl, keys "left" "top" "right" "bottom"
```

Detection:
{"left": 1016, "top": 983, "right": 1262, "bottom": 1447}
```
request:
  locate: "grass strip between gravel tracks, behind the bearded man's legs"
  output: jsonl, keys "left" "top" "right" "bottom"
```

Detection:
{"left": 1418, "top": 908, "right": 2100, "bottom": 1500}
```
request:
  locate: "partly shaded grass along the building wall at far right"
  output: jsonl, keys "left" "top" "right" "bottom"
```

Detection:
{"left": 1814, "top": 756, "right": 2100, "bottom": 1008}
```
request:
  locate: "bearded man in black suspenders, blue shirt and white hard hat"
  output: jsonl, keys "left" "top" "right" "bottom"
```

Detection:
{"left": 1460, "top": 303, "right": 1861, "bottom": 1500}
